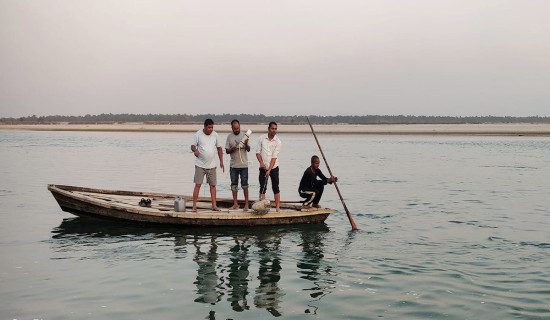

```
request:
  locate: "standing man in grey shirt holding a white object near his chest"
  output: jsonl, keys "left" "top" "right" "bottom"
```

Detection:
{"left": 225, "top": 120, "right": 250, "bottom": 211}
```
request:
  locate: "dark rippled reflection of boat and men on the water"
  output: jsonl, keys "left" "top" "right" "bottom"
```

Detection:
{"left": 52, "top": 217, "right": 335, "bottom": 319}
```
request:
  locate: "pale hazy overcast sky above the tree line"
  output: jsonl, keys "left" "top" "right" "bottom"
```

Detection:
{"left": 0, "top": 0, "right": 550, "bottom": 117}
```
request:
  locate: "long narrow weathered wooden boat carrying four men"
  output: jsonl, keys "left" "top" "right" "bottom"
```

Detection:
{"left": 48, "top": 184, "right": 334, "bottom": 226}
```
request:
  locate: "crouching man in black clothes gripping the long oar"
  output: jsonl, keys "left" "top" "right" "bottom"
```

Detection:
{"left": 298, "top": 156, "right": 338, "bottom": 210}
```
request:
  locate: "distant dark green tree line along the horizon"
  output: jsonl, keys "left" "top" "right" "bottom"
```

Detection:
{"left": 0, "top": 113, "right": 550, "bottom": 124}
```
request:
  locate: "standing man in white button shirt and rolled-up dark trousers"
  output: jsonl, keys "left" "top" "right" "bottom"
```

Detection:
{"left": 256, "top": 122, "right": 282, "bottom": 212}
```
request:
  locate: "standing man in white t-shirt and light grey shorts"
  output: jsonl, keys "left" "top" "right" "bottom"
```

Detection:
{"left": 191, "top": 119, "right": 225, "bottom": 212}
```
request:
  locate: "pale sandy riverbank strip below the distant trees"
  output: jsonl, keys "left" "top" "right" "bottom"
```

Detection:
{"left": 0, "top": 122, "right": 550, "bottom": 136}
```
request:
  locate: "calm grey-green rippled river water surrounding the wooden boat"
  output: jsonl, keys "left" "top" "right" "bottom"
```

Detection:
{"left": 0, "top": 127, "right": 550, "bottom": 319}
